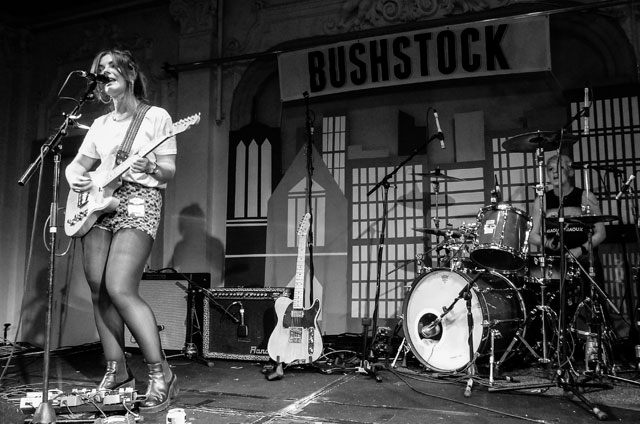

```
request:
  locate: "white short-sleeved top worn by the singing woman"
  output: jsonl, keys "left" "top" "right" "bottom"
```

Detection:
{"left": 78, "top": 106, "right": 178, "bottom": 188}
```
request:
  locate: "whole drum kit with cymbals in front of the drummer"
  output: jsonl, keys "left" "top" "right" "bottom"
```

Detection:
{"left": 394, "top": 131, "right": 617, "bottom": 383}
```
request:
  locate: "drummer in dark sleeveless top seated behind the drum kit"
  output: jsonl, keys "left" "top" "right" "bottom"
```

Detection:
{"left": 529, "top": 155, "right": 606, "bottom": 302}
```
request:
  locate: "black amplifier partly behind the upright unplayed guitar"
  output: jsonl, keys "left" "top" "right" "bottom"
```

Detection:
{"left": 202, "top": 287, "right": 293, "bottom": 361}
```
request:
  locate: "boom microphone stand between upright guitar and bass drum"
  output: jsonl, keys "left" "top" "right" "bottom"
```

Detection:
{"left": 361, "top": 133, "right": 440, "bottom": 382}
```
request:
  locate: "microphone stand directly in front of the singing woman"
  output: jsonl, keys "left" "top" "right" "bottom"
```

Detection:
{"left": 18, "top": 81, "right": 97, "bottom": 424}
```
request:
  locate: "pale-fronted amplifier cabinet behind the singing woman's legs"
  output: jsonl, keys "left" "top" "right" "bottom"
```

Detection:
{"left": 125, "top": 273, "right": 211, "bottom": 350}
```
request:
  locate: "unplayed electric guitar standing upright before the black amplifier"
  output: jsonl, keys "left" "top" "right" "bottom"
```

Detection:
{"left": 267, "top": 213, "right": 323, "bottom": 364}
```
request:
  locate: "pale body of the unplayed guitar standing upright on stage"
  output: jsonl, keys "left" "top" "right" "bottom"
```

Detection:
{"left": 267, "top": 296, "right": 323, "bottom": 364}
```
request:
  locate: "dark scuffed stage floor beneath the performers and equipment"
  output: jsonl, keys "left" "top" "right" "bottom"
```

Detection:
{"left": 0, "top": 345, "right": 640, "bottom": 424}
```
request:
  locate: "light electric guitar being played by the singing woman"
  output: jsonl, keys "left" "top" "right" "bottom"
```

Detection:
{"left": 64, "top": 113, "right": 200, "bottom": 237}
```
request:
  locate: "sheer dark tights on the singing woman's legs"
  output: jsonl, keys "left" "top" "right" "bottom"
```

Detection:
{"left": 82, "top": 227, "right": 163, "bottom": 363}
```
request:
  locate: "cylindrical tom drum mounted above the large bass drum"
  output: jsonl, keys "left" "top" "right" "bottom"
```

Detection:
{"left": 470, "top": 203, "right": 532, "bottom": 272}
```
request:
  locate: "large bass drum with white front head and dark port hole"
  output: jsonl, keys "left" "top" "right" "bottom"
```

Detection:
{"left": 403, "top": 268, "right": 526, "bottom": 371}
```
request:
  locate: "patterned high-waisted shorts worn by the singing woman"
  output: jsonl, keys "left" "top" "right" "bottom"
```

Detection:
{"left": 94, "top": 181, "right": 162, "bottom": 239}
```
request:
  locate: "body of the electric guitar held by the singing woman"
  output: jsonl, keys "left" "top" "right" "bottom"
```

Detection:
{"left": 64, "top": 171, "right": 120, "bottom": 237}
